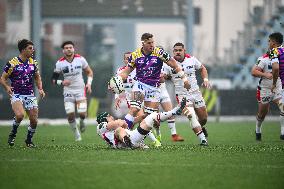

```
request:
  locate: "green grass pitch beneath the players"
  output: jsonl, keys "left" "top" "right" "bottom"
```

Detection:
{"left": 0, "top": 122, "right": 284, "bottom": 189}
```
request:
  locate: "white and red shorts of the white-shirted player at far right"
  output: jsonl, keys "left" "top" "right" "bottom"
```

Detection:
{"left": 256, "top": 88, "right": 283, "bottom": 104}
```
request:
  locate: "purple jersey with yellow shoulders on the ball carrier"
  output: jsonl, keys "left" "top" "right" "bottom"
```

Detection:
{"left": 128, "top": 47, "right": 171, "bottom": 87}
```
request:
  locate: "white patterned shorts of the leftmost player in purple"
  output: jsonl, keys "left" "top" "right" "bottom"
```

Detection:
{"left": 11, "top": 94, "right": 38, "bottom": 110}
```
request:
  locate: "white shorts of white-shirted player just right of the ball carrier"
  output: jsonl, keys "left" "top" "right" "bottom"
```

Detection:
{"left": 176, "top": 90, "right": 206, "bottom": 108}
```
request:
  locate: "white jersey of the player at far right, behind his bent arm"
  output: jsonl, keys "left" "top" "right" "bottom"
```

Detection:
{"left": 255, "top": 54, "right": 281, "bottom": 89}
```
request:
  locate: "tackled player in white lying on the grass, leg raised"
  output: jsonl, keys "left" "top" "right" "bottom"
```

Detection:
{"left": 97, "top": 99, "right": 186, "bottom": 149}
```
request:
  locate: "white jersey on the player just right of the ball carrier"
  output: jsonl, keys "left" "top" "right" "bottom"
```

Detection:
{"left": 162, "top": 56, "right": 202, "bottom": 95}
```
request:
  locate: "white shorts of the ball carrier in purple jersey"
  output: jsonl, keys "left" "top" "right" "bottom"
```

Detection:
{"left": 132, "top": 81, "right": 161, "bottom": 102}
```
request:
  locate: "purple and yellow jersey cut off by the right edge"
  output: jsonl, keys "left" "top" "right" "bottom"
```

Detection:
{"left": 269, "top": 46, "right": 284, "bottom": 89}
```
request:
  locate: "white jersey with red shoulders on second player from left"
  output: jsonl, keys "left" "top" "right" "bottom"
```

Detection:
{"left": 54, "top": 54, "right": 88, "bottom": 91}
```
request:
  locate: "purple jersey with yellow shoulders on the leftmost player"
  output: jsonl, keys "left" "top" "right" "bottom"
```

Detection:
{"left": 3, "top": 57, "right": 38, "bottom": 95}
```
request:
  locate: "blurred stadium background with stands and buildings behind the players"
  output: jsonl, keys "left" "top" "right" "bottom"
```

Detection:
{"left": 0, "top": 0, "right": 284, "bottom": 122}
